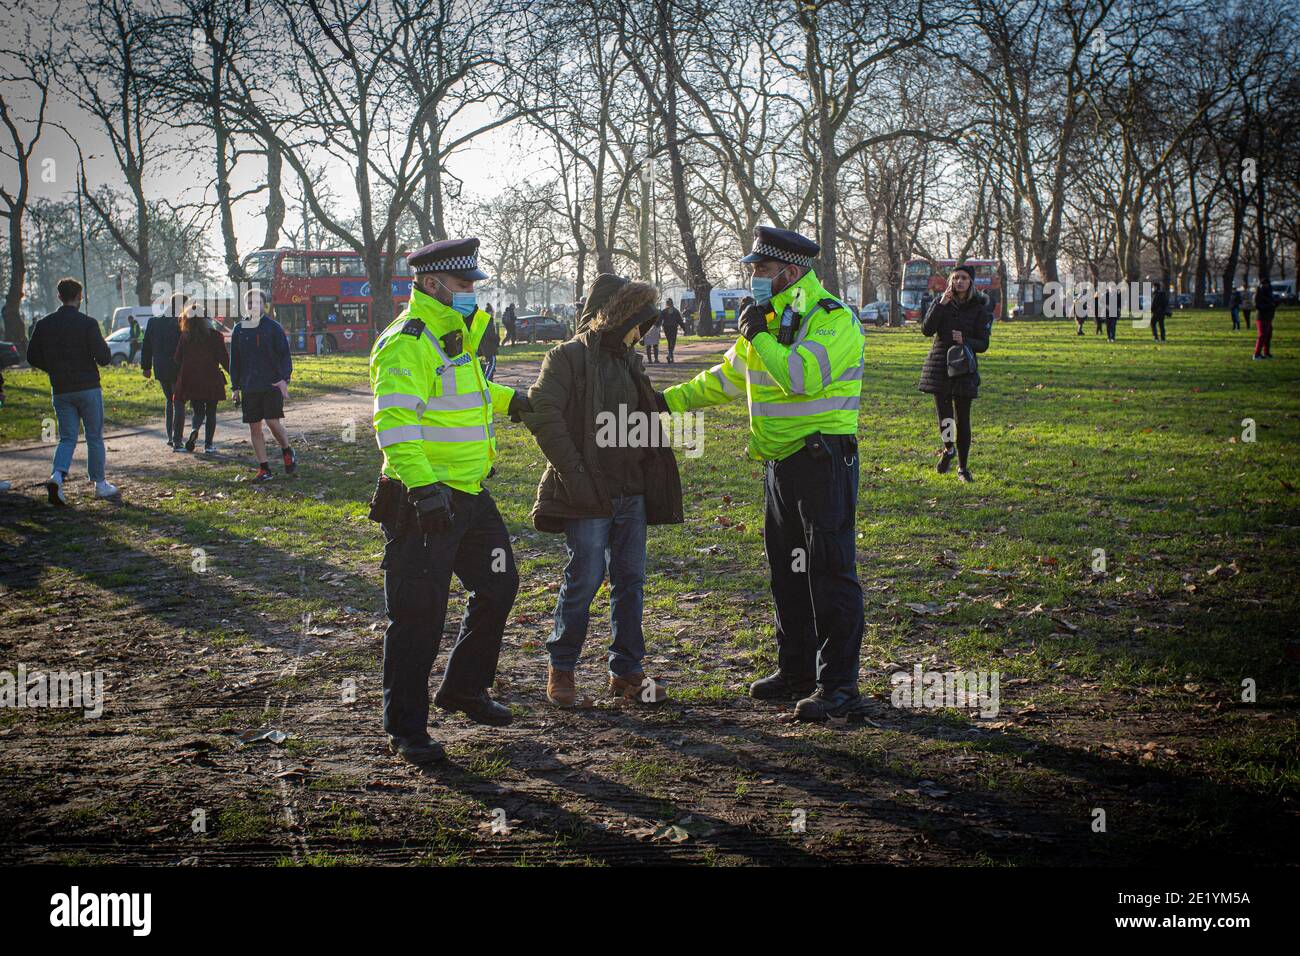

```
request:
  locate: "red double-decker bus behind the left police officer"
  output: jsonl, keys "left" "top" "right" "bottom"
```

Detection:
{"left": 243, "top": 248, "right": 411, "bottom": 354}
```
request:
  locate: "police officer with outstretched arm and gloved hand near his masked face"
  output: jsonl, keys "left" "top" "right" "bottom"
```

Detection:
{"left": 660, "top": 226, "right": 866, "bottom": 721}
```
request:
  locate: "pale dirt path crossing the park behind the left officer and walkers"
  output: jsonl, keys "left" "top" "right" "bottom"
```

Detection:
{"left": 0, "top": 338, "right": 728, "bottom": 490}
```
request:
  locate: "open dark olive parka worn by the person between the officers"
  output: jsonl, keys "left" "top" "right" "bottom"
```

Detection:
{"left": 524, "top": 283, "right": 683, "bottom": 532}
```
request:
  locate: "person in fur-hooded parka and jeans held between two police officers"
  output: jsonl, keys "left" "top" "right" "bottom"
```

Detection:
{"left": 524, "top": 274, "right": 683, "bottom": 706}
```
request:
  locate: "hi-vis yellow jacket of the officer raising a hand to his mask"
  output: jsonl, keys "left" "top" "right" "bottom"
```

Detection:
{"left": 663, "top": 269, "right": 867, "bottom": 460}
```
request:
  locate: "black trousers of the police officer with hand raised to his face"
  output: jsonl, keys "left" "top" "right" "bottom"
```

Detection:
{"left": 763, "top": 434, "right": 865, "bottom": 691}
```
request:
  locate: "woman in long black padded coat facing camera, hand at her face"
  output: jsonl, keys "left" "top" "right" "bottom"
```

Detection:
{"left": 917, "top": 265, "right": 993, "bottom": 483}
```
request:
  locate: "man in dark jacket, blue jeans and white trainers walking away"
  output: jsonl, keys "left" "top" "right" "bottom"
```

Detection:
{"left": 27, "top": 278, "right": 117, "bottom": 506}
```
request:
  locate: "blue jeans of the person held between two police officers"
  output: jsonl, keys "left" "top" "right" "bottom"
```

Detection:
{"left": 546, "top": 494, "right": 646, "bottom": 678}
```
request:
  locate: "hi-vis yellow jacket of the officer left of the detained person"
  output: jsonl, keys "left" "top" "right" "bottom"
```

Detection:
{"left": 371, "top": 287, "right": 515, "bottom": 494}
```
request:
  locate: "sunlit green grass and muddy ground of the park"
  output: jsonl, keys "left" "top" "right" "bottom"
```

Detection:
{"left": 0, "top": 312, "right": 1300, "bottom": 865}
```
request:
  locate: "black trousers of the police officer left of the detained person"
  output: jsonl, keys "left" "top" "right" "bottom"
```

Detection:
{"left": 382, "top": 489, "right": 519, "bottom": 740}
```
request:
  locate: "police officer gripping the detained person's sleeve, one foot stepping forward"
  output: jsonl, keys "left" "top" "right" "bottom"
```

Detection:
{"left": 371, "top": 238, "right": 528, "bottom": 763}
